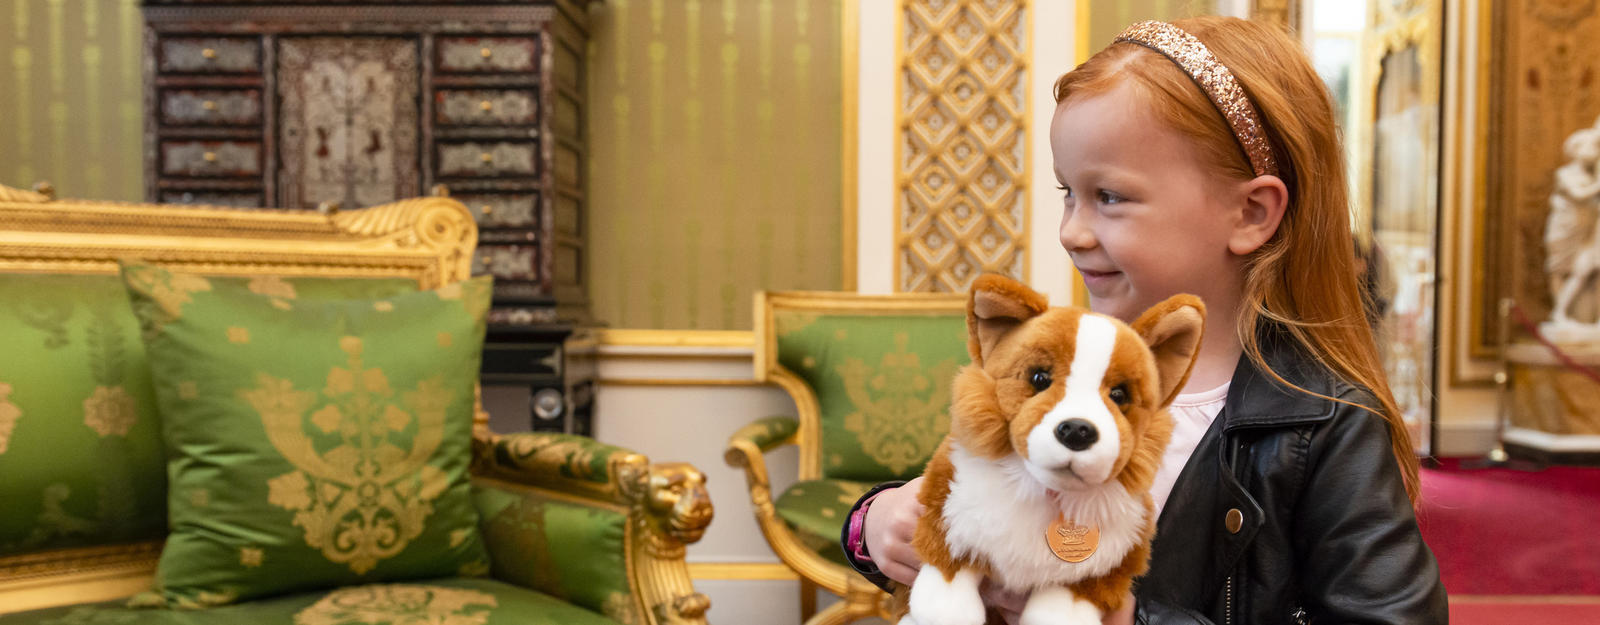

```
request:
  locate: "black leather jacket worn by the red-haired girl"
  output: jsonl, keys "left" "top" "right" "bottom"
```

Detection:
{"left": 851, "top": 330, "right": 1450, "bottom": 625}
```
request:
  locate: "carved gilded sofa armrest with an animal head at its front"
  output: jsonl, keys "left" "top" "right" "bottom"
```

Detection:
{"left": 472, "top": 432, "right": 712, "bottom": 623}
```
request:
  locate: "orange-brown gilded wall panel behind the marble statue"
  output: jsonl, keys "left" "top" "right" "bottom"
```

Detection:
{"left": 1467, "top": 0, "right": 1600, "bottom": 358}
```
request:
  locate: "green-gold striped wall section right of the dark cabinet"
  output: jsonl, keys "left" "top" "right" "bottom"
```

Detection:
{"left": 586, "top": 0, "right": 843, "bottom": 329}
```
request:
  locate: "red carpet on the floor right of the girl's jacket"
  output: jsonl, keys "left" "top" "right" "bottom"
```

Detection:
{"left": 1418, "top": 459, "right": 1600, "bottom": 594}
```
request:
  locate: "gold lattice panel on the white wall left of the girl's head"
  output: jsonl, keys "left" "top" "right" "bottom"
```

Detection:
{"left": 894, "top": 0, "right": 1029, "bottom": 293}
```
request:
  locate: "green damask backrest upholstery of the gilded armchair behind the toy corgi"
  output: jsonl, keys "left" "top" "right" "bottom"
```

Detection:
{"left": 773, "top": 310, "right": 968, "bottom": 481}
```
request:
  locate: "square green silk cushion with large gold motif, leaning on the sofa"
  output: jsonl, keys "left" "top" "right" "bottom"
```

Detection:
{"left": 123, "top": 265, "right": 490, "bottom": 607}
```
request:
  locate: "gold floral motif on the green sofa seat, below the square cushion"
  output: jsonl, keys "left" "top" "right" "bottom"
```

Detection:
{"left": 294, "top": 583, "right": 499, "bottom": 625}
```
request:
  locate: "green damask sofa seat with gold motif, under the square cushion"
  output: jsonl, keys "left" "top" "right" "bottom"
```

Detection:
{"left": 0, "top": 579, "right": 626, "bottom": 625}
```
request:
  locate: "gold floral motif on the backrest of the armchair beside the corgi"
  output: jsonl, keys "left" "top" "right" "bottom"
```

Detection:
{"left": 838, "top": 332, "right": 958, "bottom": 473}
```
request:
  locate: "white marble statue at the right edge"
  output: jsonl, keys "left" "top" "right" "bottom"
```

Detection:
{"left": 1541, "top": 120, "right": 1600, "bottom": 342}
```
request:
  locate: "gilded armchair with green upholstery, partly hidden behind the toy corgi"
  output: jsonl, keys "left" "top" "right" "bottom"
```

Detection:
{"left": 726, "top": 293, "right": 968, "bottom": 625}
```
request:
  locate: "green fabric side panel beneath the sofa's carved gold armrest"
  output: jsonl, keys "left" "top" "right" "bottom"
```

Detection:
{"left": 474, "top": 481, "right": 640, "bottom": 623}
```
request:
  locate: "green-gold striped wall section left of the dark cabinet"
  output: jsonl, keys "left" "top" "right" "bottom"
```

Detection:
{"left": 0, "top": 0, "right": 144, "bottom": 201}
